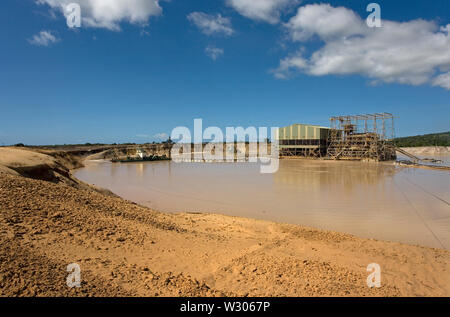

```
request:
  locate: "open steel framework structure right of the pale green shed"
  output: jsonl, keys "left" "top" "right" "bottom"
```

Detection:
{"left": 327, "top": 112, "right": 396, "bottom": 161}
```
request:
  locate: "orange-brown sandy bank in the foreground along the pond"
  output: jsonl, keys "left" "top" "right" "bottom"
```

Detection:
{"left": 0, "top": 148, "right": 450, "bottom": 296}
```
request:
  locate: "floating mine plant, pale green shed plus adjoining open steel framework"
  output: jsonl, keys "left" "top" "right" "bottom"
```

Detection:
{"left": 278, "top": 113, "right": 396, "bottom": 161}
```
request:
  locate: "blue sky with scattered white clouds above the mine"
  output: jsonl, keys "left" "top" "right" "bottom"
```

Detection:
{"left": 0, "top": 0, "right": 450, "bottom": 145}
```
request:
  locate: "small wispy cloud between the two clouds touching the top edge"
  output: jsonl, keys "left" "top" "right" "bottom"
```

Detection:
{"left": 187, "top": 12, "right": 234, "bottom": 36}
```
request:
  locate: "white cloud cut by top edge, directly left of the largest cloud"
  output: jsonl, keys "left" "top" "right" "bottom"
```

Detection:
{"left": 227, "top": 0, "right": 299, "bottom": 24}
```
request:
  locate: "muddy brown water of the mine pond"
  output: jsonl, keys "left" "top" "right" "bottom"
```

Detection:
{"left": 75, "top": 160, "right": 450, "bottom": 250}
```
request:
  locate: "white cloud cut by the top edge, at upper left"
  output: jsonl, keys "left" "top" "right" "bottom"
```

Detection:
{"left": 36, "top": 0, "right": 162, "bottom": 31}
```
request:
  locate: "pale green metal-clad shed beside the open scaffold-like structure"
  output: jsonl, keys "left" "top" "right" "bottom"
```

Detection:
{"left": 277, "top": 124, "right": 330, "bottom": 157}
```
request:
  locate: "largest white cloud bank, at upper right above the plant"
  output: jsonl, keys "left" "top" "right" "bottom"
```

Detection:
{"left": 273, "top": 4, "right": 450, "bottom": 89}
